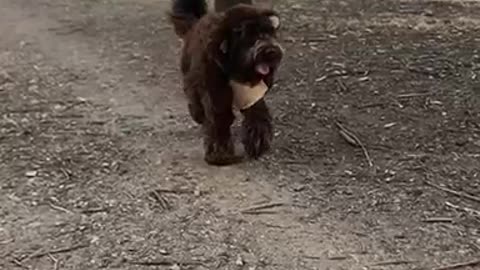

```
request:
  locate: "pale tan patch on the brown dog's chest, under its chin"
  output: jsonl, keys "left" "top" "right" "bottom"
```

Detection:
{"left": 230, "top": 80, "right": 268, "bottom": 110}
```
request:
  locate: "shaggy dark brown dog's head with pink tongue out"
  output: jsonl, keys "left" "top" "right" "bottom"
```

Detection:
{"left": 214, "top": 5, "right": 283, "bottom": 83}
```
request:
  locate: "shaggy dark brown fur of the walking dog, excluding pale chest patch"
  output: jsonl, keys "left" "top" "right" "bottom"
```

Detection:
{"left": 170, "top": 0, "right": 283, "bottom": 165}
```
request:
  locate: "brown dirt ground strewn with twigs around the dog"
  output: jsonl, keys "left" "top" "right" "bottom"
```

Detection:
{"left": 0, "top": 0, "right": 480, "bottom": 270}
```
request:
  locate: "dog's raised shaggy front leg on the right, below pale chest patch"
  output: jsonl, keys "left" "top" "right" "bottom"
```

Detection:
{"left": 241, "top": 99, "right": 273, "bottom": 159}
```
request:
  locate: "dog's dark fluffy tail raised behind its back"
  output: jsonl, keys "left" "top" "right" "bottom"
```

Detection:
{"left": 169, "top": 0, "right": 207, "bottom": 38}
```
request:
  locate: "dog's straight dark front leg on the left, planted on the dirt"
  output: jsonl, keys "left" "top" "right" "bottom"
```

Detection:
{"left": 202, "top": 97, "right": 241, "bottom": 166}
